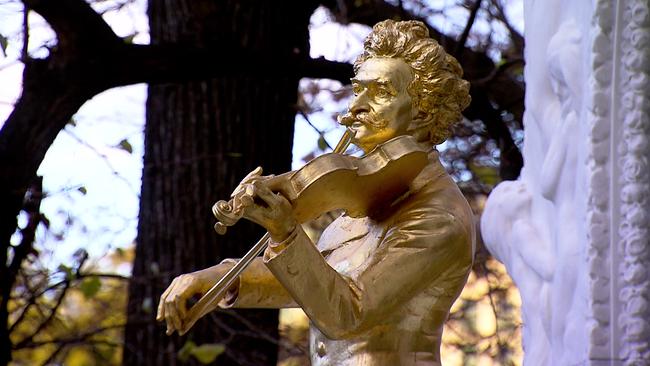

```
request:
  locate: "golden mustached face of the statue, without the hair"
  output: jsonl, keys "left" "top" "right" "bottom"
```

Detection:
{"left": 350, "top": 57, "right": 416, "bottom": 152}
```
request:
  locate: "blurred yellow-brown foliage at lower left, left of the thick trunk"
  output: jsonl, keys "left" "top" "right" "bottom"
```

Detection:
{"left": 9, "top": 244, "right": 133, "bottom": 366}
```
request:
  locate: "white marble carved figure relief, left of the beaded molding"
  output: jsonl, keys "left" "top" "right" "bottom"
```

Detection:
{"left": 481, "top": 1, "right": 588, "bottom": 365}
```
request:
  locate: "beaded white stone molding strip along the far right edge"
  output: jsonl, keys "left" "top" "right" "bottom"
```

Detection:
{"left": 604, "top": 0, "right": 650, "bottom": 365}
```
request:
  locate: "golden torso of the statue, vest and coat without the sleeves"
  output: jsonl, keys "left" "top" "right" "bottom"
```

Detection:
{"left": 310, "top": 159, "right": 473, "bottom": 365}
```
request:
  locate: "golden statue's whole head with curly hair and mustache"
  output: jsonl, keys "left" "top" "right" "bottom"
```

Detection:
{"left": 341, "top": 20, "right": 470, "bottom": 152}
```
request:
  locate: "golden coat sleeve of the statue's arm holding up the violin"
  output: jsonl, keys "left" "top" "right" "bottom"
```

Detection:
{"left": 264, "top": 206, "right": 473, "bottom": 339}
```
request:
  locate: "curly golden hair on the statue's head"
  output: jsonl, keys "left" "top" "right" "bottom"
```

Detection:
{"left": 354, "top": 20, "right": 471, "bottom": 144}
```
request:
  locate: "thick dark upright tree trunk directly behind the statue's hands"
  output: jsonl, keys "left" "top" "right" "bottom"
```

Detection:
{"left": 124, "top": 0, "right": 315, "bottom": 365}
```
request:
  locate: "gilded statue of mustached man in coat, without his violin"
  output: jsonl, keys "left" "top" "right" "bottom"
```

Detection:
{"left": 158, "top": 20, "right": 475, "bottom": 366}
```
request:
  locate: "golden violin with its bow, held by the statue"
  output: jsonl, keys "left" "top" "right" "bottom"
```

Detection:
{"left": 179, "top": 129, "right": 429, "bottom": 335}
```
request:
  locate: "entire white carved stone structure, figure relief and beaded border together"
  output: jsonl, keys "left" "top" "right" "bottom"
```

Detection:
{"left": 481, "top": 0, "right": 650, "bottom": 366}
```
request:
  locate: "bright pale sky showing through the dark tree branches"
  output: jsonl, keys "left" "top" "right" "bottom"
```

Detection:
{"left": 0, "top": 0, "right": 523, "bottom": 268}
